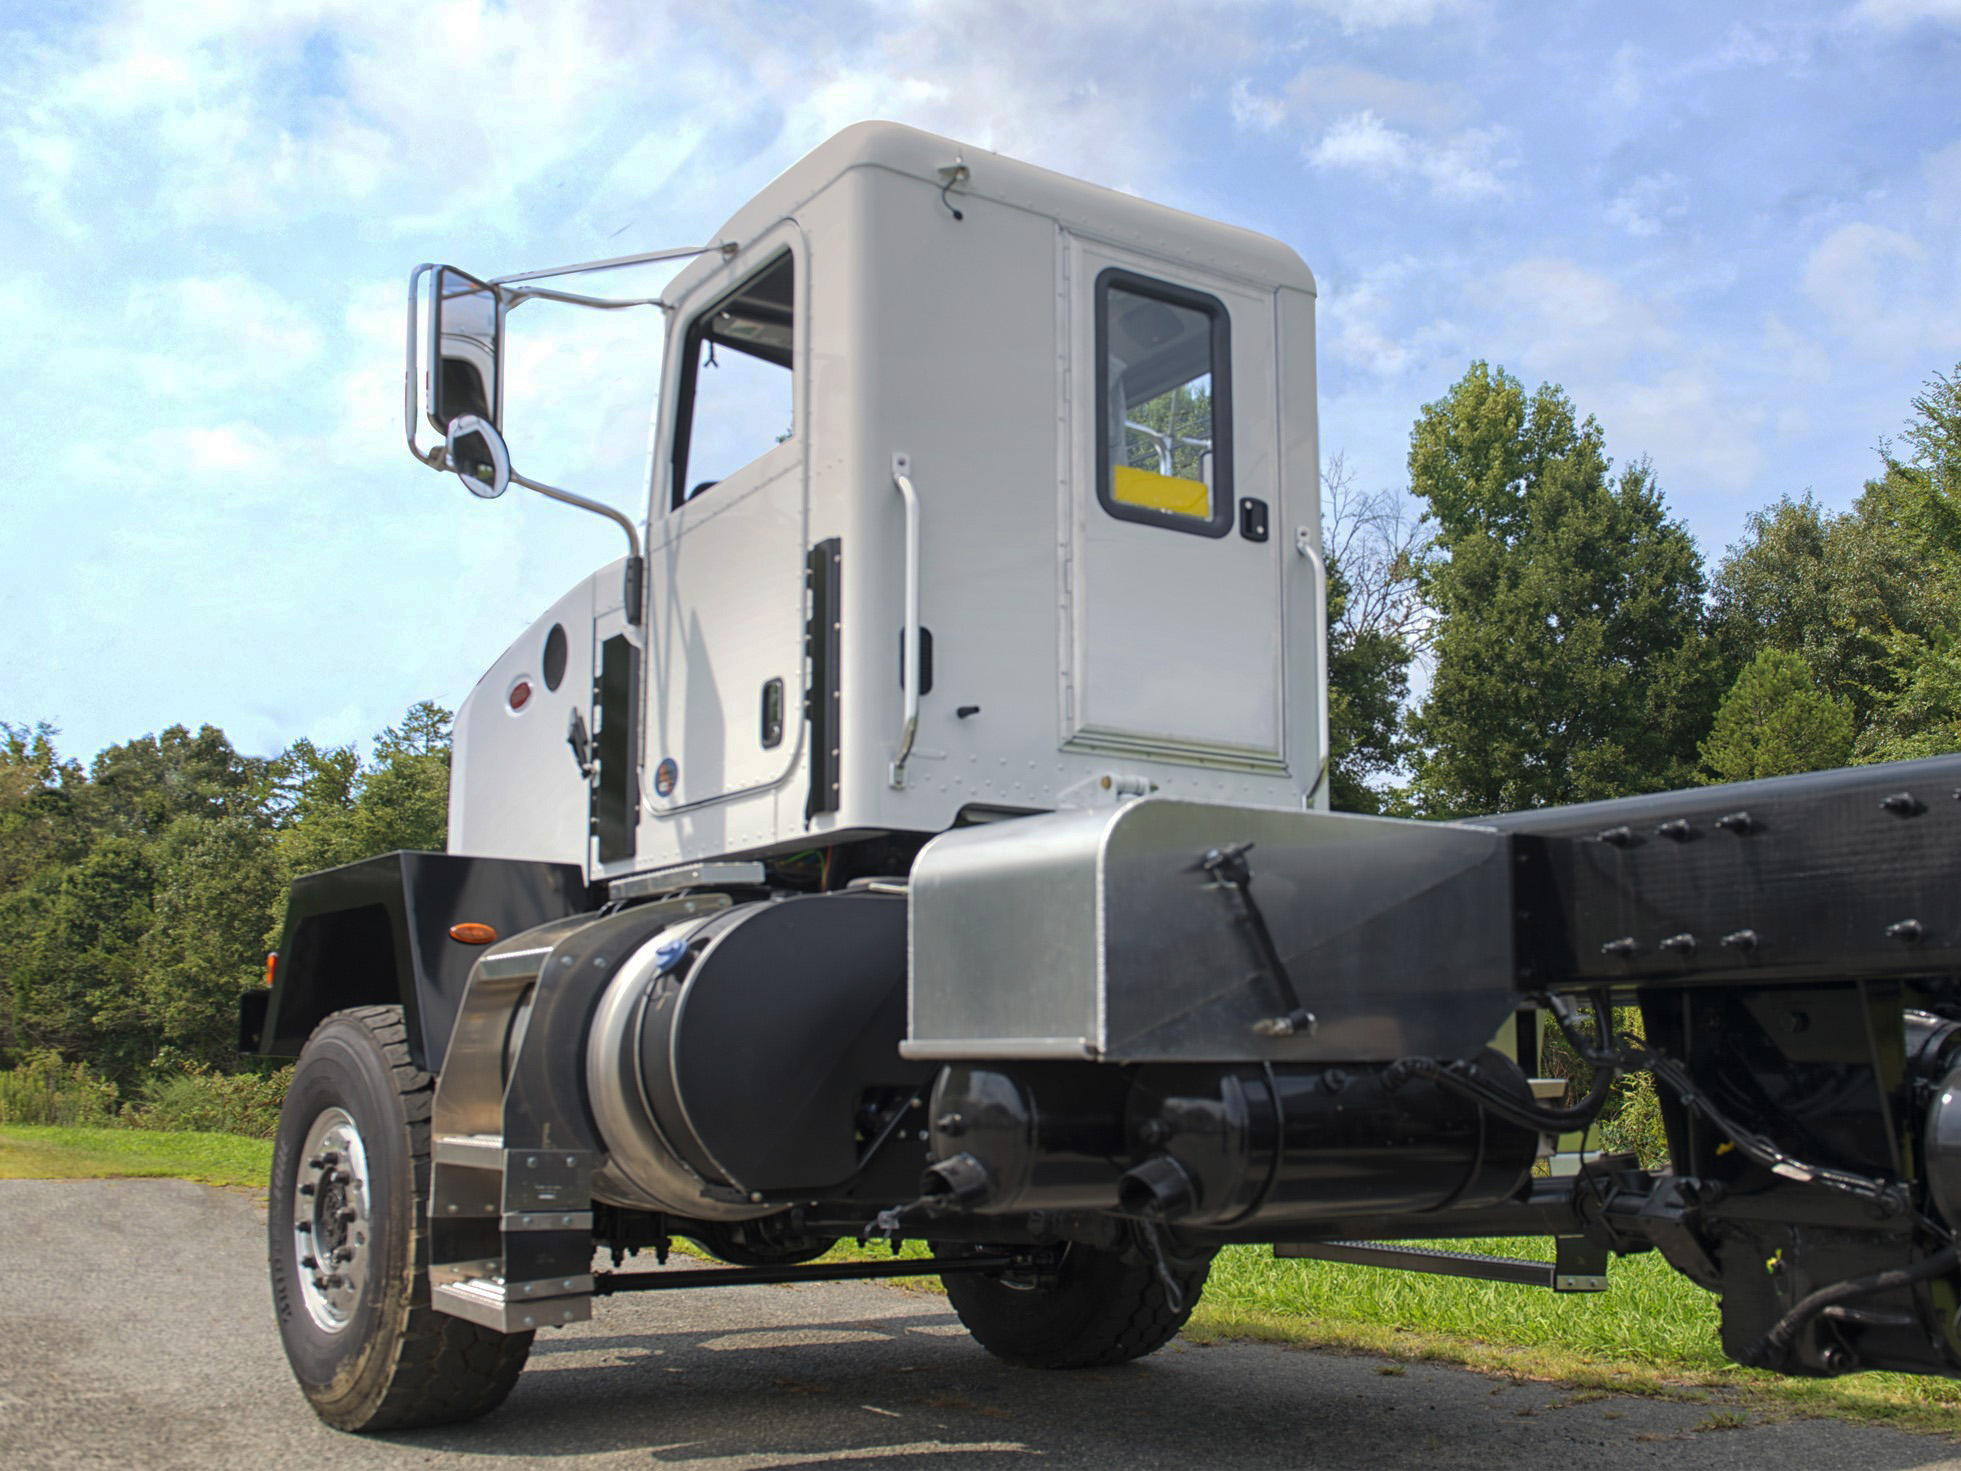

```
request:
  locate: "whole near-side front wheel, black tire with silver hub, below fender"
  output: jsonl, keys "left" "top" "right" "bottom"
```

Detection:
{"left": 267, "top": 1006, "right": 531, "bottom": 1430}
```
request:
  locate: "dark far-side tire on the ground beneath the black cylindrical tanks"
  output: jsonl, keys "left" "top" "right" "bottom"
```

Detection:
{"left": 943, "top": 1243, "right": 1212, "bottom": 1369}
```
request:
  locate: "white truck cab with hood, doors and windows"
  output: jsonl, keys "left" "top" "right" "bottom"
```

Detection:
{"left": 431, "top": 124, "right": 1328, "bottom": 879}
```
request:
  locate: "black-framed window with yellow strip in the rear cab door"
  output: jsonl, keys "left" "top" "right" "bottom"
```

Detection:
{"left": 1096, "top": 271, "right": 1232, "bottom": 535}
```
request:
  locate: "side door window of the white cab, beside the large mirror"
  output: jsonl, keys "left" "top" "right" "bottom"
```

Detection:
{"left": 675, "top": 255, "right": 796, "bottom": 506}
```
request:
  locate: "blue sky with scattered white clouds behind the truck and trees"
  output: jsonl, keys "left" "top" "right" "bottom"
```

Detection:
{"left": 0, "top": 0, "right": 1961, "bottom": 757}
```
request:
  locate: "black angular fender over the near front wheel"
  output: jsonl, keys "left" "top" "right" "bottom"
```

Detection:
{"left": 239, "top": 853, "right": 594, "bottom": 1073}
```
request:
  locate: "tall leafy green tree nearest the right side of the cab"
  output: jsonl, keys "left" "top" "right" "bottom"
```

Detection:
{"left": 1410, "top": 363, "right": 1722, "bottom": 816}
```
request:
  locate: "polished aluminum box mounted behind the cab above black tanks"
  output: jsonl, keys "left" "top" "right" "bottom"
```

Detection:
{"left": 900, "top": 798, "right": 1518, "bottom": 1063}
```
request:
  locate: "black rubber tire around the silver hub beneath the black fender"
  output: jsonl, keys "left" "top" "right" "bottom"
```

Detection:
{"left": 267, "top": 1006, "right": 531, "bottom": 1432}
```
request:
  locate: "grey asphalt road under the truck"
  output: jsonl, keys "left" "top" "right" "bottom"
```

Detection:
{"left": 0, "top": 1181, "right": 1961, "bottom": 1471}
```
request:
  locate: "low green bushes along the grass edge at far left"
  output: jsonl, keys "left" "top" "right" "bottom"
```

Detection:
{"left": 0, "top": 1051, "right": 292, "bottom": 1140}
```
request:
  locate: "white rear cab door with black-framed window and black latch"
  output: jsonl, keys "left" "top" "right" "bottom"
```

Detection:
{"left": 1061, "top": 237, "right": 1286, "bottom": 771}
